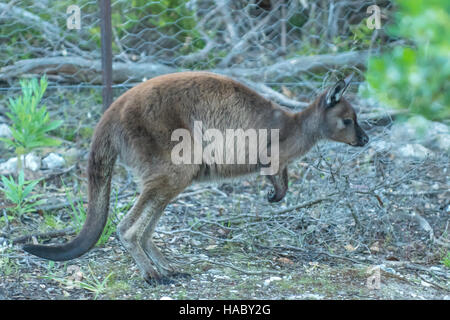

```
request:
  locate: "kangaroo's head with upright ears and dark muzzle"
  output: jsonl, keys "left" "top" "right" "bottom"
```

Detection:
{"left": 318, "top": 74, "right": 369, "bottom": 147}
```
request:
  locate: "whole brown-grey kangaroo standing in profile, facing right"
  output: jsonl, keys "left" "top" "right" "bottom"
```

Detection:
{"left": 23, "top": 72, "right": 369, "bottom": 283}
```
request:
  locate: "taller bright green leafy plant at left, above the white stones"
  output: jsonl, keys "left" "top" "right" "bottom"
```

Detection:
{"left": 0, "top": 77, "right": 62, "bottom": 171}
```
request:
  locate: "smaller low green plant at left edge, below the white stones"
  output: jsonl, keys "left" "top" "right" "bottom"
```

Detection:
{"left": 0, "top": 171, "right": 44, "bottom": 217}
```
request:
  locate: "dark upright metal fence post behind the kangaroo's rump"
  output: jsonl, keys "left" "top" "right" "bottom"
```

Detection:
{"left": 99, "top": 0, "right": 112, "bottom": 111}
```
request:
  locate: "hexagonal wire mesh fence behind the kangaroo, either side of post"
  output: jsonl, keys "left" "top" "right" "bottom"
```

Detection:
{"left": 0, "top": 0, "right": 392, "bottom": 108}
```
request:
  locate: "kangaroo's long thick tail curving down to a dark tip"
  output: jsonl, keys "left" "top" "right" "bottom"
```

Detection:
{"left": 23, "top": 121, "right": 117, "bottom": 261}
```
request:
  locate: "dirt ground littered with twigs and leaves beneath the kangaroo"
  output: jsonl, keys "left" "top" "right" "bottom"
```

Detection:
{"left": 0, "top": 92, "right": 450, "bottom": 299}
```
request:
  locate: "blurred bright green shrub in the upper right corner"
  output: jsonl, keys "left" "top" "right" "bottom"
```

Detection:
{"left": 365, "top": 0, "right": 450, "bottom": 120}
